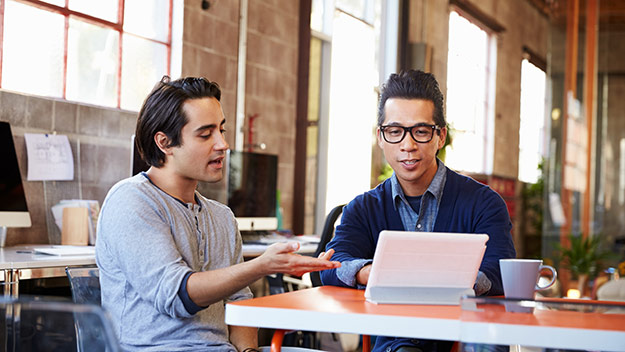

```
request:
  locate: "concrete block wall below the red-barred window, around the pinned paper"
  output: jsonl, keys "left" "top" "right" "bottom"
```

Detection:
{"left": 0, "top": 91, "right": 136, "bottom": 245}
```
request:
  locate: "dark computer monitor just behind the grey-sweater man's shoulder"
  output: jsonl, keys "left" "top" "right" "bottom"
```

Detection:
{"left": 227, "top": 151, "right": 278, "bottom": 231}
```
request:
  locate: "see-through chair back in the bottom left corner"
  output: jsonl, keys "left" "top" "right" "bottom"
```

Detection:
{"left": 0, "top": 296, "right": 121, "bottom": 352}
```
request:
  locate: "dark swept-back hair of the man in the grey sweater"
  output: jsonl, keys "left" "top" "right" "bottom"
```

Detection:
{"left": 135, "top": 76, "right": 221, "bottom": 167}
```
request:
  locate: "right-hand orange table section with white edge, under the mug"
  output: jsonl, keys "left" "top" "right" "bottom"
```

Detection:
{"left": 459, "top": 297, "right": 625, "bottom": 351}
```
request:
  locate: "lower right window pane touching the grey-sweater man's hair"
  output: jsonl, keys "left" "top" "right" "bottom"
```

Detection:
{"left": 121, "top": 34, "right": 167, "bottom": 111}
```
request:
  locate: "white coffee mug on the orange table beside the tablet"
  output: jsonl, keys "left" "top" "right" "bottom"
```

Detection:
{"left": 499, "top": 259, "right": 558, "bottom": 299}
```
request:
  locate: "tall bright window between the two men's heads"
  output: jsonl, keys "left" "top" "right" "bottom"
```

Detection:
{"left": 296, "top": 0, "right": 383, "bottom": 233}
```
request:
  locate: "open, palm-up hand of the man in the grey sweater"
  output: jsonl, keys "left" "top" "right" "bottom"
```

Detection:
{"left": 256, "top": 242, "right": 341, "bottom": 276}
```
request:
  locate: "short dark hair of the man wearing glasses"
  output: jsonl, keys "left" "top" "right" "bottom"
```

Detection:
{"left": 378, "top": 70, "right": 447, "bottom": 128}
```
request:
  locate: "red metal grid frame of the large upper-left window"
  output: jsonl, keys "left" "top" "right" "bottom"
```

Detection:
{"left": 0, "top": 0, "right": 174, "bottom": 109}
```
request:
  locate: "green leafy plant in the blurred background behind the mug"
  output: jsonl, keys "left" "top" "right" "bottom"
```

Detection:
{"left": 556, "top": 234, "right": 610, "bottom": 295}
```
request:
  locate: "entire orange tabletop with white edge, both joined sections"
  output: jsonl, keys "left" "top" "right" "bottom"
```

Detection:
{"left": 226, "top": 286, "right": 625, "bottom": 351}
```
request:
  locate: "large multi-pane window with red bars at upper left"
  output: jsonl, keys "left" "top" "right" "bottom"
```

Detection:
{"left": 0, "top": 0, "right": 174, "bottom": 110}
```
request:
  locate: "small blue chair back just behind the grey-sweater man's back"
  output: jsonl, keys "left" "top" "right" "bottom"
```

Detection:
{"left": 65, "top": 266, "right": 101, "bottom": 306}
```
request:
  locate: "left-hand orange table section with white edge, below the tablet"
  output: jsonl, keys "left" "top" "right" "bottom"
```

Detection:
{"left": 226, "top": 286, "right": 461, "bottom": 350}
